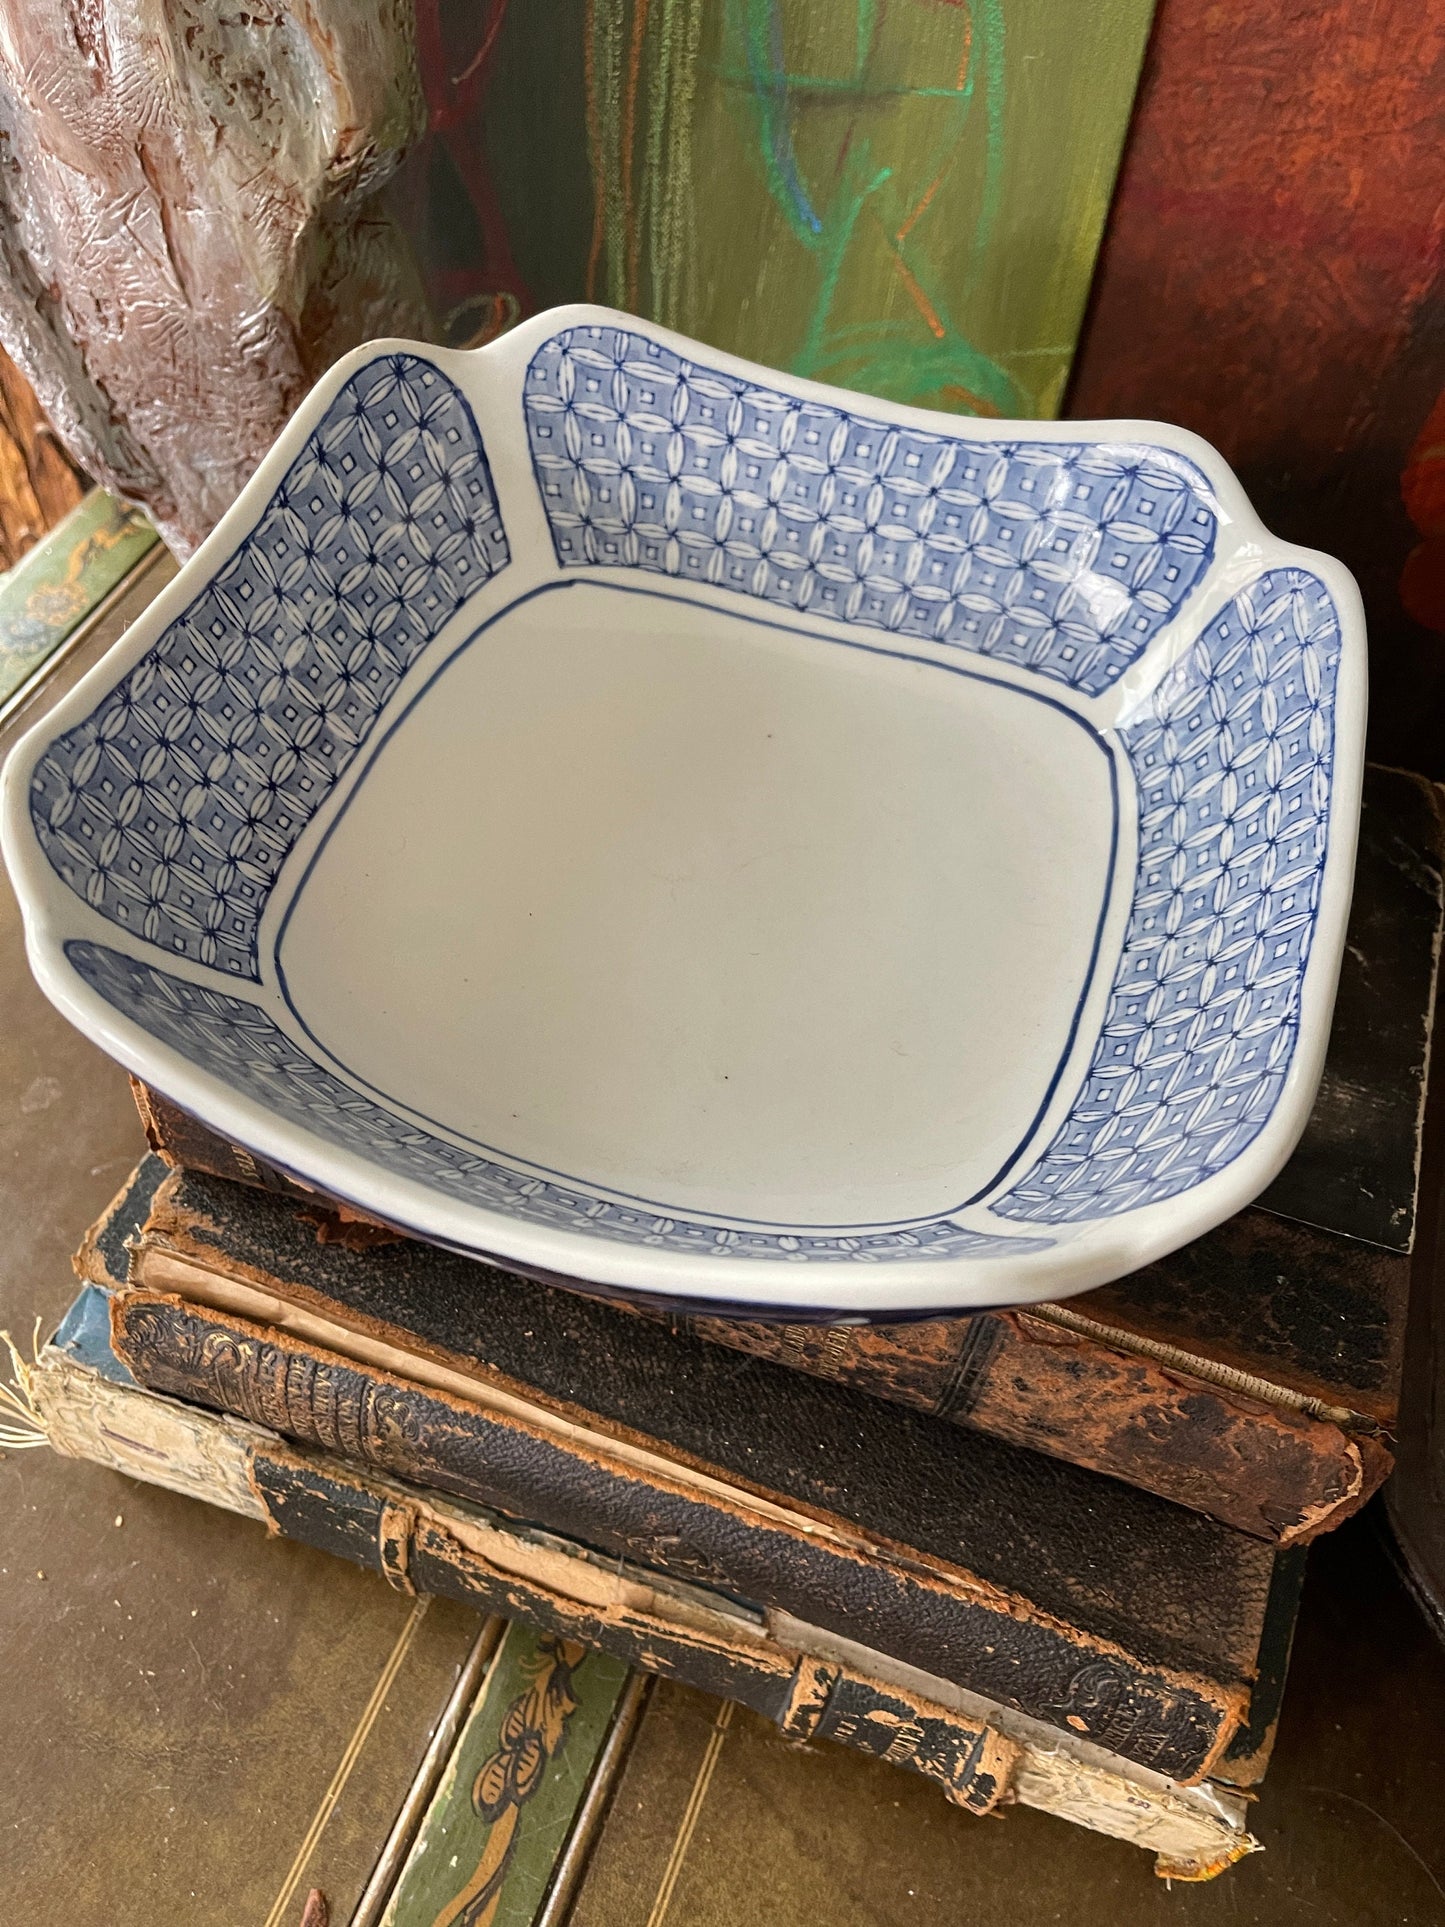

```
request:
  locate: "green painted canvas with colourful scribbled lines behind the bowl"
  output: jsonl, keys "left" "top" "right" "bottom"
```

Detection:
{"left": 401, "top": 0, "right": 1152, "bottom": 416}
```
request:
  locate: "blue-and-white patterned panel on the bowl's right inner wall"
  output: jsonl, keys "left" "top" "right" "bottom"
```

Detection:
{"left": 992, "top": 568, "right": 1339, "bottom": 1224}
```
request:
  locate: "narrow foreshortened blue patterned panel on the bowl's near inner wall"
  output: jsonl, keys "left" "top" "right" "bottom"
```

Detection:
{"left": 66, "top": 942, "right": 1054, "bottom": 1264}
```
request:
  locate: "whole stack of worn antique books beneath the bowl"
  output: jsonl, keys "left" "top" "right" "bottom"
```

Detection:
{"left": 27, "top": 771, "right": 1441, "bottom": 1877}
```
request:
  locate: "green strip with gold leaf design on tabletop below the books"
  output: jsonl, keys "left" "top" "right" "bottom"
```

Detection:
{"left": 381, "top": 1624, "right": 628, "bottom": 1927}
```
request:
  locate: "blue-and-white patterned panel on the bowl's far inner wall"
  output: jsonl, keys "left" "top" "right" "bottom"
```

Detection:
{"left": 524, "top": 328, "right": 1218, "bottom": 696}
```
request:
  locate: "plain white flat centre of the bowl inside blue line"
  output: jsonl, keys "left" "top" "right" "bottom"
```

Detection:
{"left": 276, "top": 584, "right": 1117, "bottom": 1227}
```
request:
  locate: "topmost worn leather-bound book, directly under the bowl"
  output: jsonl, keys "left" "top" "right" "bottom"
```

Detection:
{"left": 137, "top": 769, "right": 1441, "bottom": 1545}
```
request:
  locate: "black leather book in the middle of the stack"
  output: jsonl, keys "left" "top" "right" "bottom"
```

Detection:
{"left": 81, "top": 1158, "right": 1293, "bottom": 1781}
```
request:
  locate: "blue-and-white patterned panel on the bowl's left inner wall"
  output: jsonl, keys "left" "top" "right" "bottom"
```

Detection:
{"left": 31, "top": 355, "right": 507, "bottom": 977}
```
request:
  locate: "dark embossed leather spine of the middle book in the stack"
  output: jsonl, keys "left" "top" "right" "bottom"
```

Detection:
{"left": 112, "top": 1289, "right": 1248, "bottom": 1782}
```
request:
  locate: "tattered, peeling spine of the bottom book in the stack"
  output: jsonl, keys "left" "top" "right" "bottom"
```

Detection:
{"left": 25, "top": 1325, "right": 1258, "bottom": 1879}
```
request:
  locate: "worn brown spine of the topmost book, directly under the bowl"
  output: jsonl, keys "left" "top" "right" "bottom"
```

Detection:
{"left": 135, "top": 1083, "right": 1391, "bottom": 1545}
